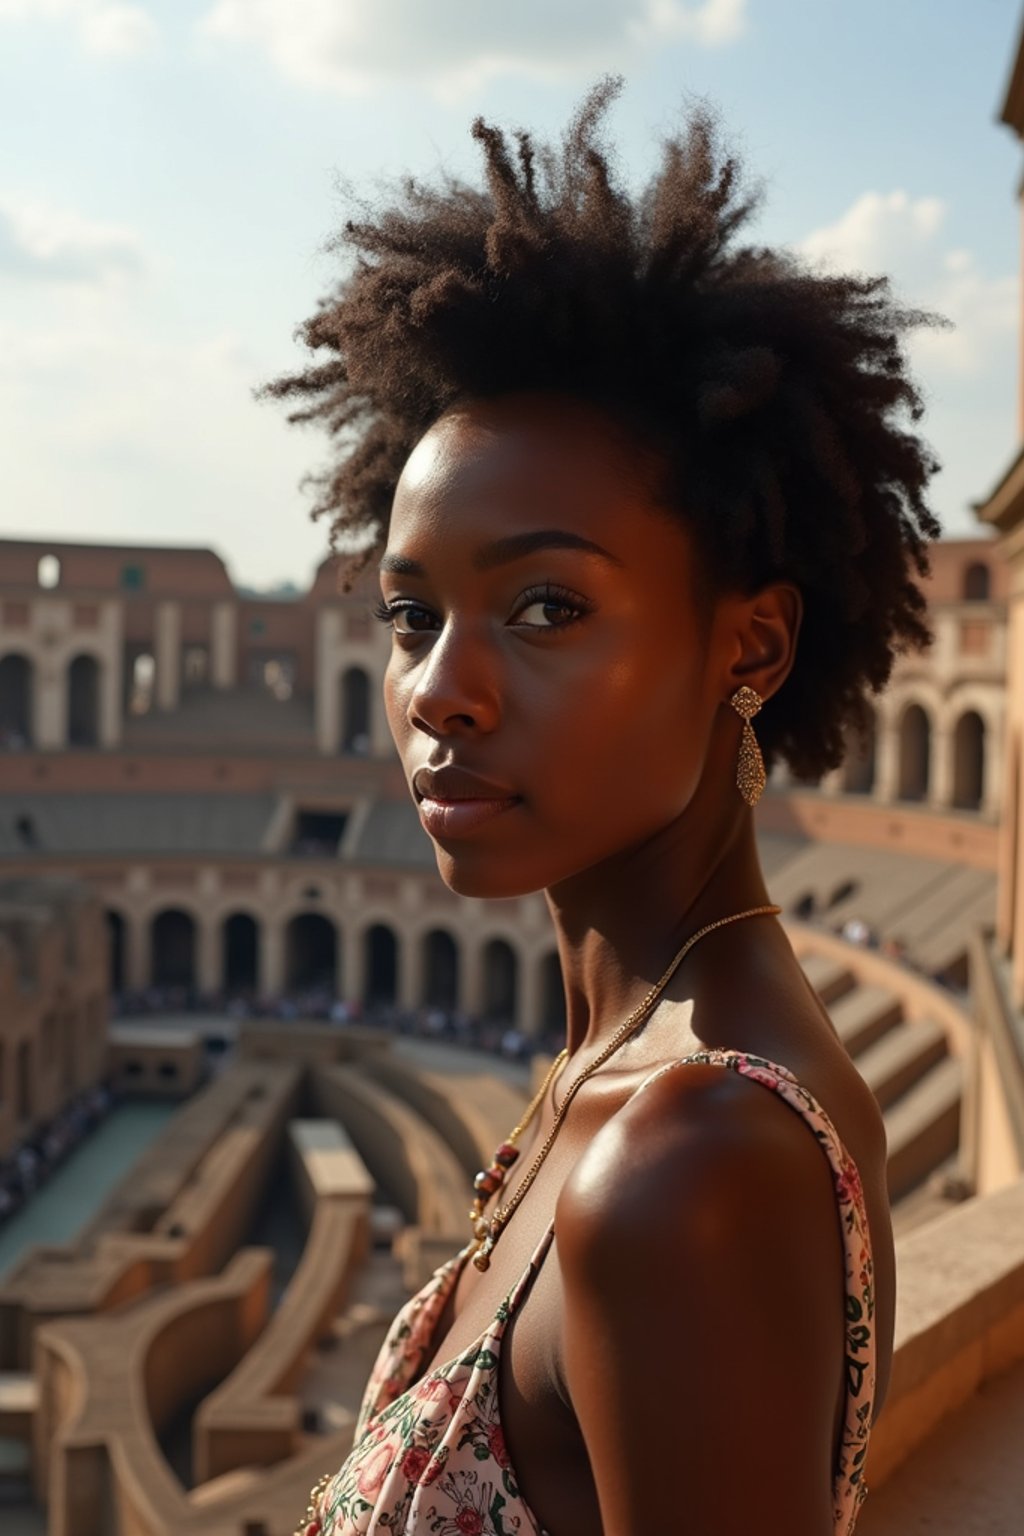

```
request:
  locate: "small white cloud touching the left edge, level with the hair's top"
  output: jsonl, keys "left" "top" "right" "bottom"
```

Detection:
{"left": 0, "top": 198, "right": 146, "bottom": 283}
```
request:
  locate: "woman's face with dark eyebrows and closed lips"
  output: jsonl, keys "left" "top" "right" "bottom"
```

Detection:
{"left": 381, "top": 395, "right": 734, "bottom": 897}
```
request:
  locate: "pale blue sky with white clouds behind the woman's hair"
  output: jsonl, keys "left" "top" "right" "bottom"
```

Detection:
{"left": 0, "top": 0, "right": 1024, "bottom": 588}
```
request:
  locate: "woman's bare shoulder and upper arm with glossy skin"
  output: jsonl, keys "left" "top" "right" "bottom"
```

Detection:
{"left": 556, "top": 1068, "right": 844, "bottom": 1536}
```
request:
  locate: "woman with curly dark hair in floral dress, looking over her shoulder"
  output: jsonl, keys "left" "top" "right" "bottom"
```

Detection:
{"left": 270, "top": 84, "right": 938, "bottom": 1536}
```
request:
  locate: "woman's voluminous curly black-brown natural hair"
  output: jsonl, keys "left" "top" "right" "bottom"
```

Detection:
{"left": 263, "top": 80, "right": 940, "bottom": 779}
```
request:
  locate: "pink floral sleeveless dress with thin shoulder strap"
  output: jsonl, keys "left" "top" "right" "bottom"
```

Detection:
{"left": 310, "top": 1051, "right": 875, "bottom": 1536}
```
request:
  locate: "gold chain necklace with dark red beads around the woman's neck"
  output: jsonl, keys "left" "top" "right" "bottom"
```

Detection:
{"left": 470, "top": 906, "right": 781, "bottom": 1270}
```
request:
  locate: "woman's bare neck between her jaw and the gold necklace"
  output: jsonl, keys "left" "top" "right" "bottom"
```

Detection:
{"left": 547, "top": 806, "right": 769, "bottom": 1055}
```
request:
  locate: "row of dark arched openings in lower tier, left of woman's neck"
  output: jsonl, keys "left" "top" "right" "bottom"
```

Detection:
{"left": 107, "top": 908, "right": 565, "bottom": 1029}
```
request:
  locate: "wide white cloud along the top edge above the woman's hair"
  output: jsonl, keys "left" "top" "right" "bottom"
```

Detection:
{"left": 200, "top": 0, "right": 748, "bottom": 95}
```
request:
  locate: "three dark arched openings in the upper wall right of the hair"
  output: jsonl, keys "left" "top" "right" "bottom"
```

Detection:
{"left": 841, "top": 703, "right": 987, "bottom": 811}
